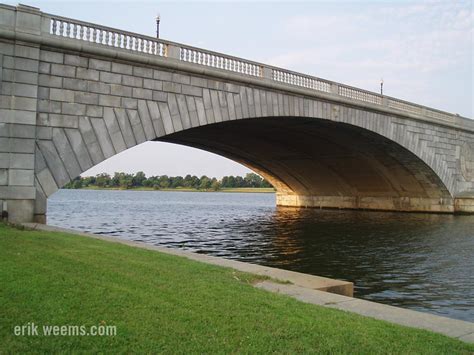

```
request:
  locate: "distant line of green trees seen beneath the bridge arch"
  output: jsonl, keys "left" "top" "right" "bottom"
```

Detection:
{"left": 64, "top": 171, "right": 272, "bottom": 191}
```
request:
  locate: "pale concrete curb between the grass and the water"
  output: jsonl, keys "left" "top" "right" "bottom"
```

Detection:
{"left": 22, "top": 223, "right": 474, "bottom": 343}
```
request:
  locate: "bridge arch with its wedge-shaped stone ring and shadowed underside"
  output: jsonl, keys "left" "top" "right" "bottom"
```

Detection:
{"left": 37, "top": 94, "right": 453, "bottom": 218}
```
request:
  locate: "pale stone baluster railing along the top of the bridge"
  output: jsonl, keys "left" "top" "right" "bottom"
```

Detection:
{"left": 43, "top": 10, "right": 457, "bottom": 122}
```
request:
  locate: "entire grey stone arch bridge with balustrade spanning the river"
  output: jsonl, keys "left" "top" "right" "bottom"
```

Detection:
{"left": 0, "top": 5, "right": 474, "bottom": 222}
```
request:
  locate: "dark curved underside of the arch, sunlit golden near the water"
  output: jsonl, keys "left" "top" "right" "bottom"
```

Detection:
{"left": 160, "top": 117, "right": 455, "bottom": 212}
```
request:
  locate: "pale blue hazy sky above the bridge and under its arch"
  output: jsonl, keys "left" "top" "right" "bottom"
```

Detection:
{"left": 5, "top": 0, "right": 474, "bottom": 177}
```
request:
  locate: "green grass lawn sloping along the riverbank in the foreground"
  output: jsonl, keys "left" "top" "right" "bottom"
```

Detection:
{"left": 0, "top": 224, "right": 474, "bottom": 354}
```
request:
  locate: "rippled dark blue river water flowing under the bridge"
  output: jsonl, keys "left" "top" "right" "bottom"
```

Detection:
{"left": 48, "top": 190, "right": 474, "bottom": 322}
